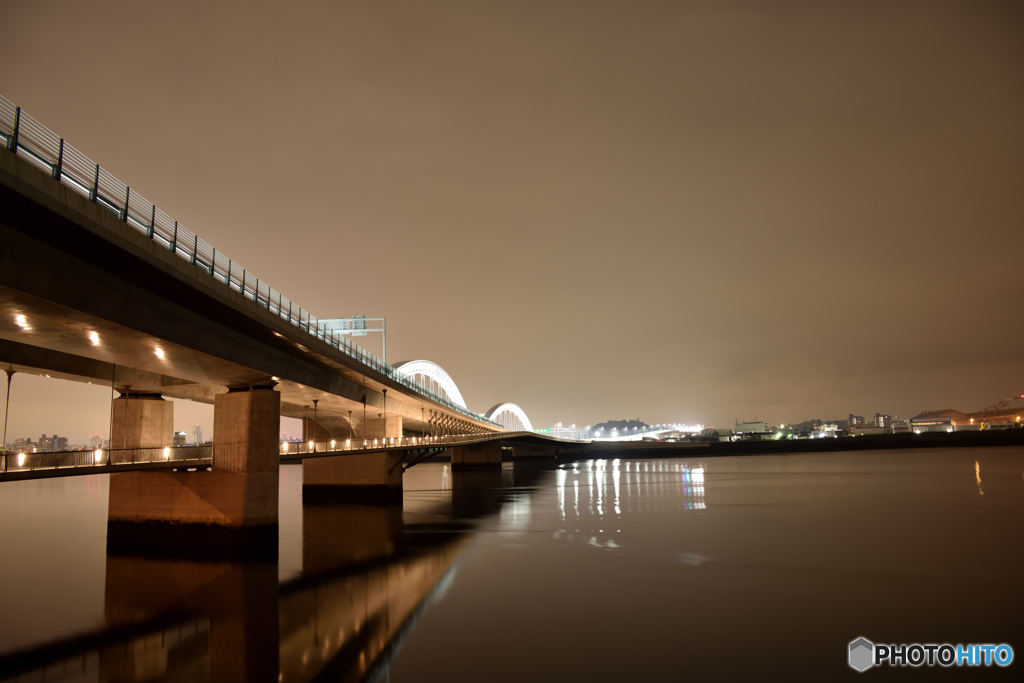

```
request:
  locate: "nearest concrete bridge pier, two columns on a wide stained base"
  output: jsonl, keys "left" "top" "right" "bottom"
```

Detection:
{"left": 108, "top": 387, "right": 281, "bottom": 539}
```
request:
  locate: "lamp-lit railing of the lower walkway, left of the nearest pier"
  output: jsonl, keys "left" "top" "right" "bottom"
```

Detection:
{"left": 0, "top": 445, "right": 213, "bottom": 472}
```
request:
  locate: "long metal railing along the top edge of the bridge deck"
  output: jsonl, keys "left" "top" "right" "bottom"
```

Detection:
{"left": 0, "top": 95, "right": 501, "bottom": 427}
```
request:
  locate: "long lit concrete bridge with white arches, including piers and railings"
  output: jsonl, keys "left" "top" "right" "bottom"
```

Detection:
{"left": 0, "top": 97, "right": 585, "bottom": 528}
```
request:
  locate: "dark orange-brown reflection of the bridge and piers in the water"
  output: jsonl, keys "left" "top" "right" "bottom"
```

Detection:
{"left": 0, "top": 468, "right": 543, "bottom": 683}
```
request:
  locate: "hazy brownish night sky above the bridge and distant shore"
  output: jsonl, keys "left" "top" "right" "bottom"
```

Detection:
{"left": 0, "top": 0, "right": 1024, "bottom": 440}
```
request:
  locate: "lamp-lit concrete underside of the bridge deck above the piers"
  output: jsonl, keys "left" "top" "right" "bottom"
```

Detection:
{"left": 0, "top": 286, "right": 468, "bottom": 437}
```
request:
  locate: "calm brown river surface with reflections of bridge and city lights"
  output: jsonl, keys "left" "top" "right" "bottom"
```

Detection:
{"left": 0, "top": 447, "right": 1024, "bottom": 682}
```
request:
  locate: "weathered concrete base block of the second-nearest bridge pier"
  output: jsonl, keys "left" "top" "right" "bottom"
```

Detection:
{"left": 302, "top": 452, "right": 404, "bottom": 503}
